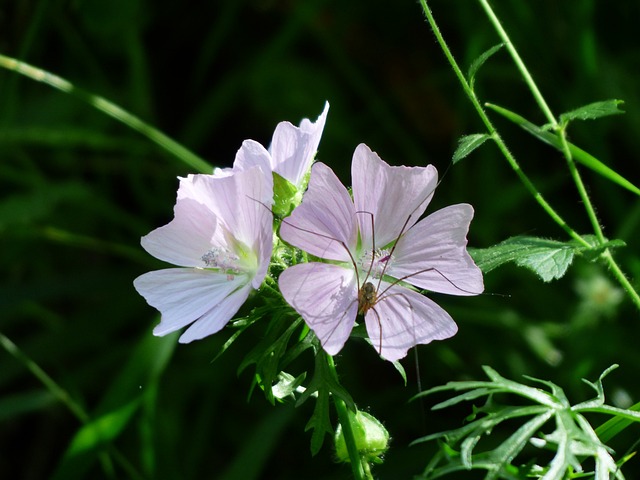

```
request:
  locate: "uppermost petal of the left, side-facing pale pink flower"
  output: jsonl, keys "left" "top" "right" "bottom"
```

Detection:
{"left": 178, "top": 166, "right": 273, "bottom": 251}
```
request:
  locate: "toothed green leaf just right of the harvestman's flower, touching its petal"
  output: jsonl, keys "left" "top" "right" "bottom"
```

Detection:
{"left": 469, "top": 236, "right": 578, "bottom": 282}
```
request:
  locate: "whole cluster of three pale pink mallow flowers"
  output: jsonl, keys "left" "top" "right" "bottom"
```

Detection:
{"left": 134, "top": 104, "right": 483, "bottom": 361}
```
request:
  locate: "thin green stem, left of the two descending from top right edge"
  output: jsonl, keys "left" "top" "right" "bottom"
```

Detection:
{"left": 420, "top": 0, "right": 589, "bottom": 246}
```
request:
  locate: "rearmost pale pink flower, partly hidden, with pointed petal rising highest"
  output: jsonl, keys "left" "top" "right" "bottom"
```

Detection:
{"left": 214, "top": 102, "right": 329, "bottom": 189}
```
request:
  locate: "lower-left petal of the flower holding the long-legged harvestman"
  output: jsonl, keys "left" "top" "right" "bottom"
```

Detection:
{"left": 278, "top": 262, "right": 358, "bottom": 355}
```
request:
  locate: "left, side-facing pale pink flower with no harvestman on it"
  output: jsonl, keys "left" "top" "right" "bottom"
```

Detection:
{"left": 134, "top": 167, "right": 273, "bottom": 343}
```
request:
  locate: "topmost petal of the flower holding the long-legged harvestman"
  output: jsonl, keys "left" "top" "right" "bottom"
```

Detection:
{"left": 351, "top": 144, "right": 438, "bottom": 248}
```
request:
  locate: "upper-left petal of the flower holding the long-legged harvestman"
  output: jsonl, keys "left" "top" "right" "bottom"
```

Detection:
{"left": 280, "top": 163, "right": 358, "bottom": 262}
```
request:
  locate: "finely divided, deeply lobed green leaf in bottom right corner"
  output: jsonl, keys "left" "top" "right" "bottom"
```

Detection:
{"left": 414, "top": 365, "right": 640, "bottom": 480}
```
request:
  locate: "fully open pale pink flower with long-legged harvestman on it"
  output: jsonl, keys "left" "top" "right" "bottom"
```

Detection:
{"left": 279, "top": 144, "right": 484, "bottom": 361}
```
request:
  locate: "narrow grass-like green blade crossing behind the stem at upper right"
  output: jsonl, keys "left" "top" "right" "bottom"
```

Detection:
{"left": 486, "top": 103, "right": 640, "bottom": 195}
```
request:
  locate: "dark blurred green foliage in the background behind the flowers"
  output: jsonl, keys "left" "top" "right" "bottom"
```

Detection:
{"left": 0, "top": 0, "right": 640, "bottom": 480}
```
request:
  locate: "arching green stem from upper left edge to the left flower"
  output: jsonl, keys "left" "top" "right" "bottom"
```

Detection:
{"left": 0, "top": 55, "right": 213, "bottom": 173}
